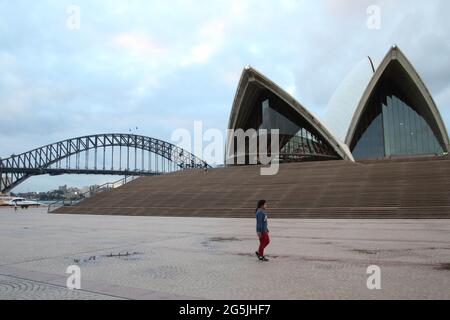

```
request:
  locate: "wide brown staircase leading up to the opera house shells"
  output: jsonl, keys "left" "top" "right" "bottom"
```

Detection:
{"left": 55, "top": 157, "right": 450, "bottom": 219}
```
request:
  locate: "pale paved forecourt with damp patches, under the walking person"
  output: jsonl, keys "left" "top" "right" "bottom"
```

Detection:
{"left": 0, "top": 208, "right": 450, "bottom": 299}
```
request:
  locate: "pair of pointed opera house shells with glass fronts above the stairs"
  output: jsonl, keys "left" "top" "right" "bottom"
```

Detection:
{"left": 226, "top": 46, "right": 449, "bottom": 163}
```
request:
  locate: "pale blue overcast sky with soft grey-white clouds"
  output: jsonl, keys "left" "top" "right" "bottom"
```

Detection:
{"left": 0, "top": 0, "right": 450, "bottom": 191}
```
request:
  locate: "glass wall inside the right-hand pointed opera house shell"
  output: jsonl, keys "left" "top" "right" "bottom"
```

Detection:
{"left": 351, "top": 81, "right": 444, "bottom": 159}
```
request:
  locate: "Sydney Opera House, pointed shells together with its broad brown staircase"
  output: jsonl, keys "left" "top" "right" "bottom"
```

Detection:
{"left": 57, "top": 46, "right": 450, "bottom": 218}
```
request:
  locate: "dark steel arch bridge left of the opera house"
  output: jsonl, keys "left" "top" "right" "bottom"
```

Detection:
{"left": 0, "top": 133, "right": 210, "bottom": 193}
